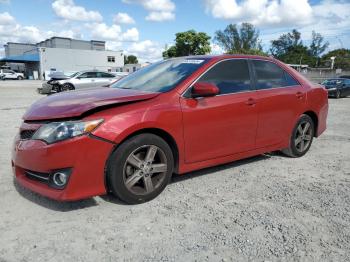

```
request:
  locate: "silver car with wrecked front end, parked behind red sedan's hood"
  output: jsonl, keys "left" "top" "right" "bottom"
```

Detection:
{"left": 38, "top": 70, "right": 118, "bottom": 94}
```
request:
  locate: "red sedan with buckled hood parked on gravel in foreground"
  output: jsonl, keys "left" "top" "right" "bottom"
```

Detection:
{"left": 12, "top": 55, "right": 328, "bottom": 204}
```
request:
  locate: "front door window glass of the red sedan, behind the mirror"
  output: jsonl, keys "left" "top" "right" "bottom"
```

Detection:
{"left": 198, "top": 59, "right": 251, "bottom": 94}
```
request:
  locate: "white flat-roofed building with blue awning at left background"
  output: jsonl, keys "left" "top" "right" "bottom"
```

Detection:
{"left": 0, "top": 37, "right": 124, "bottom": 79}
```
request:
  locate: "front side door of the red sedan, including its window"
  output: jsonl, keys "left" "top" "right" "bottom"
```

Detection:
{"left": 180, "top": 59, "right": 257, "bottom": 163}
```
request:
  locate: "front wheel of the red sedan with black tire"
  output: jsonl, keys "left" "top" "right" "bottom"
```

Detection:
{"left": 106, "top": 134, "right": 174, "bottom": 204}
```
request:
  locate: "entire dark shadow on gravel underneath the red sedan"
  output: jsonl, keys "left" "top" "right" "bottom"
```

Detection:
{"left": 13, "top": 152, "right": 281, "bottom": 212}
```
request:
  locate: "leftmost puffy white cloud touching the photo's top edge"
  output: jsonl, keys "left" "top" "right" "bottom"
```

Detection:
{"left": 52, "top": 0, "right": 102, "bottom": 22}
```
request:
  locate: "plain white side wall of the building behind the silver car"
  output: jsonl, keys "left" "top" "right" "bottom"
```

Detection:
{"left": 39, "top": 47, "right": 124, "bottom": 74}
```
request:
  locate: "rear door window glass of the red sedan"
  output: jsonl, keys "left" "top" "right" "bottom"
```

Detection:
{"left": 252, "top": 60, "right": 299, "bottom": 89}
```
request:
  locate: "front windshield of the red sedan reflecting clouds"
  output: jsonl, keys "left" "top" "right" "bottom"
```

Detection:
{"left": 112, "top": 58, "right": 209, "bottom": 92}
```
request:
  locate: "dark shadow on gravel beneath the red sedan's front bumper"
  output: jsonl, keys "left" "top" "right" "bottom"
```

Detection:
{"left": 13, "top": 179, "right": 98, "bottom": 212}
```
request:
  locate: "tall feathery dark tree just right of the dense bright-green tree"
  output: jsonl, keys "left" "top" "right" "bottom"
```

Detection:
{"left": 214, "top": 23, "right": 266, "bottom": 55}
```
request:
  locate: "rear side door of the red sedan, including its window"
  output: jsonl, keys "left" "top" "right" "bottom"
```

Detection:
{"left": 251, "top": 60, "right": 306, "bottom": 148}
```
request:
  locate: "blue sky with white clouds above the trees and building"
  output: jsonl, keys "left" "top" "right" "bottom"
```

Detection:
{"left": 0, "top": 0, "right": 350, "bottom": 62}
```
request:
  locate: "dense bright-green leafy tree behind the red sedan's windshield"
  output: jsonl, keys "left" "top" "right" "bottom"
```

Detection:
{"left": 163, "top": 30, "right": 210, "bottom": 58}
